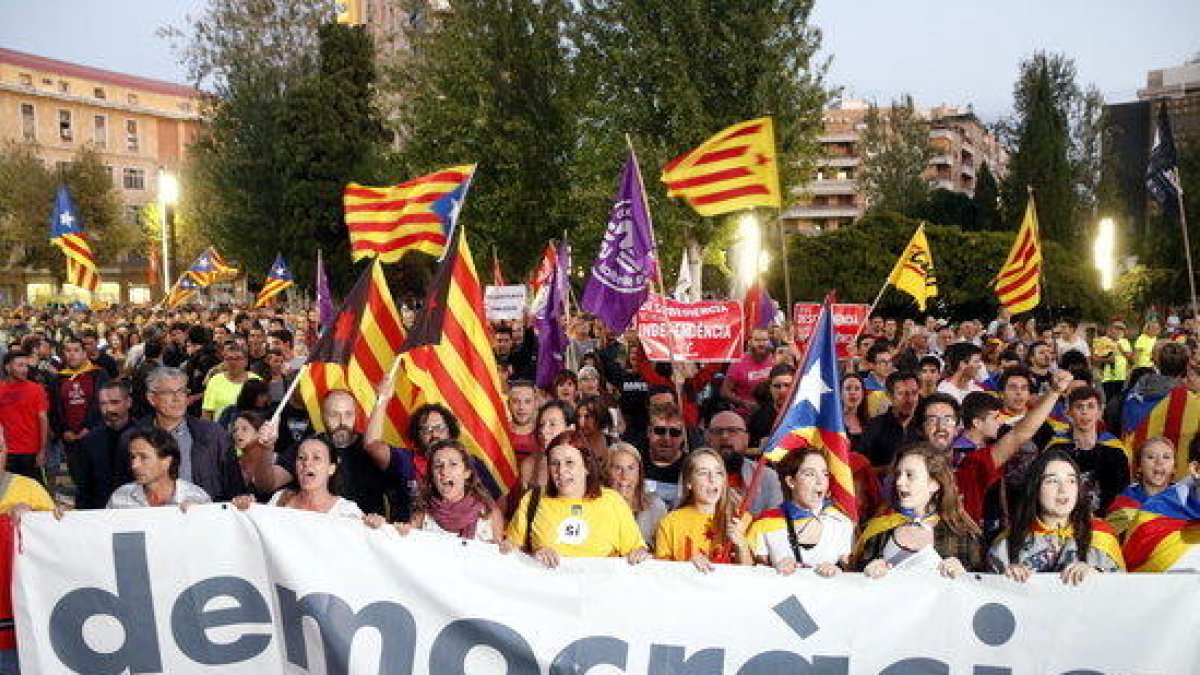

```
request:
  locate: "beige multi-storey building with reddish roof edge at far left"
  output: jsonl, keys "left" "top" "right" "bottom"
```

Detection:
{"left": 0, "top": 48, "right": 202, "bottom": 304}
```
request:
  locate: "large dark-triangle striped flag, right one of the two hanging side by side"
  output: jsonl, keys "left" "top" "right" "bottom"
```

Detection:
{"left": 397, "top": 228, "right": 517, "bottom": 490}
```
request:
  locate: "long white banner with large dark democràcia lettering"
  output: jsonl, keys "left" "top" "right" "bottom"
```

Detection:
{"left": 14, "top": 506, "right": 1200, "bottom": 675}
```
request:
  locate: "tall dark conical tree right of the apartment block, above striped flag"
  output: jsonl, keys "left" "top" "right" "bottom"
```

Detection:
{"left": 1001, "top": 52, "right": 1103, "bottom": 246}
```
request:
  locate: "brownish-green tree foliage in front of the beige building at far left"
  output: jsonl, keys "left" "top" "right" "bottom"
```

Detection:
{"left": 0, "top": 143, "right": 135, "bottom": 276}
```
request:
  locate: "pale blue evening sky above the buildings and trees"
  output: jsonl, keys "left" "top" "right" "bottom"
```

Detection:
{"left": 0, "top": 0, "right": 1200, "bottom": 123}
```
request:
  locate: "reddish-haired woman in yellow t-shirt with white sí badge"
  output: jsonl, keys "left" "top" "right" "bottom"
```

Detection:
{"left": 505, "top": 431, "right": 650, "bottom": 567}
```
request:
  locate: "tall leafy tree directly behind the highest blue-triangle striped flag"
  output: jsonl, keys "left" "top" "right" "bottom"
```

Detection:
{"left": 383, "top": 0, "right": 578, "bottom": 275}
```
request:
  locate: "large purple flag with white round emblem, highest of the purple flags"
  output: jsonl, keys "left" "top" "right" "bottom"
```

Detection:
{"left": 580, "top": 150, "right": 659, "bottom": 333}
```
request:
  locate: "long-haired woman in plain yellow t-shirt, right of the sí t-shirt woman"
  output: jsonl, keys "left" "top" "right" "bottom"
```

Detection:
{"left": 654, "top": 448, "right": 754, "bottom": 572}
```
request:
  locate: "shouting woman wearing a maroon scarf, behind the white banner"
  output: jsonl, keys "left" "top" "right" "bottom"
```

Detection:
{"left": 405, "top": 440, "right": 504, "bottom": 543}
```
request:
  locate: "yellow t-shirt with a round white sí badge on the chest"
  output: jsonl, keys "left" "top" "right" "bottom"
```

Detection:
{"left": 508, "top": 488, "right": 646, "bottom": 557}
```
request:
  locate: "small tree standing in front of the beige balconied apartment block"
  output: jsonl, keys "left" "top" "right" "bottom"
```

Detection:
{"left": 858, "top": 95, "right": 934, "bottom": 215}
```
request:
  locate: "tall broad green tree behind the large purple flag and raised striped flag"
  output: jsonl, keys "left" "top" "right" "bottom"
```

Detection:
{"left": 572, "top": 0, "right": 829, "bottom": 281}
